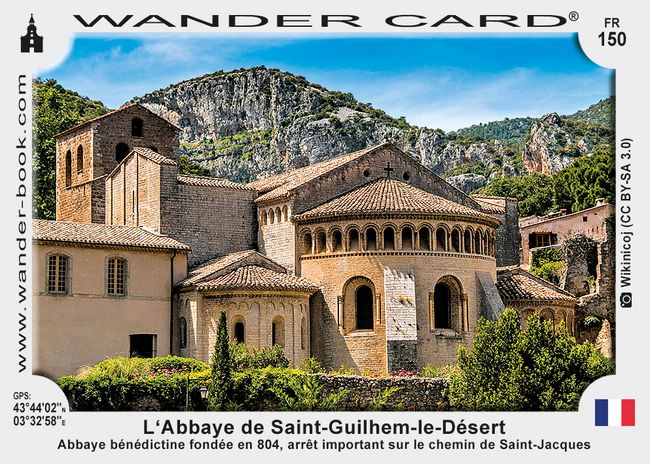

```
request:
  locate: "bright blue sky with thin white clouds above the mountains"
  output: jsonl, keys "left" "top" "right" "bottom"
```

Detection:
{"left": 40, "top": 34, "right": 613, "bottom": 130}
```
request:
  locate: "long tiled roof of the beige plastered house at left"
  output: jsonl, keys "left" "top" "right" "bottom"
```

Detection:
{"left": 32, "top": 219, "right": 190, "bottom": 251}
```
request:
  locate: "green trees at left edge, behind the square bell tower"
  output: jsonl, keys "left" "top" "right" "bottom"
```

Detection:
{"left": 33, "top": 79, "right": 108, "bottom": 219}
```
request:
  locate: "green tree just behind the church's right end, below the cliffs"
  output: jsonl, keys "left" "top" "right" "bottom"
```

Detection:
{"left": 477, "top": 173, "right": 555, "bottom": 217}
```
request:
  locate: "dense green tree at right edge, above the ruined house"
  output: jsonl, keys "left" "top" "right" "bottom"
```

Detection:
{"left": 553, "top": 148, "right": 616, "bottom": 212}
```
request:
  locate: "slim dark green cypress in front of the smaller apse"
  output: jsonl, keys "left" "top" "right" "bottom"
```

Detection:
{"left": 208, "top": 311, "right": 233, "bottom": 411}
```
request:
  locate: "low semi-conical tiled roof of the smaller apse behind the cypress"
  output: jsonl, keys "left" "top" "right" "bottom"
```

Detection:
{"left": 196, "top": 266, "right": 318, "bottom": 293}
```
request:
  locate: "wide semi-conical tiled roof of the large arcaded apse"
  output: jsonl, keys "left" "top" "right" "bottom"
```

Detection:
{"left": 294, "top": 177, "right": 496, "bottom": 222}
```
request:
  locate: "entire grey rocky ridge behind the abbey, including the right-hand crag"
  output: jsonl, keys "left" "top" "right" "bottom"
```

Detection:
{"left": 133, "top": 67, "right": 612, "bottom": 188}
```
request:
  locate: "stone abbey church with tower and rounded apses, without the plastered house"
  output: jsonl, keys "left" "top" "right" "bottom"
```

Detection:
{"left": 39, "top": 105, "right": 572, "bottom": 373}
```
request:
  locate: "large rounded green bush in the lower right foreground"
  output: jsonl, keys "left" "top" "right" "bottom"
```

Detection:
{"left": 449, "top": 308, "right": 613, "bottom": 411}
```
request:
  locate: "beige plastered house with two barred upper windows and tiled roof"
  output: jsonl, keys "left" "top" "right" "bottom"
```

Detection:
{"left": 32, "top": 219, "right": 189, "bottom": 377}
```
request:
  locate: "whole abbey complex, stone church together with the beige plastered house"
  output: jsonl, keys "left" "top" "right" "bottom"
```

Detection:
{"left": 33, "top": 104, "right": 577, "bottom": 377}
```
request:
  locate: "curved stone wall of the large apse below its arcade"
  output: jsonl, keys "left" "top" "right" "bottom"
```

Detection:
{"left": 299, "top": 220, "right": 496, "bottom": 373}
